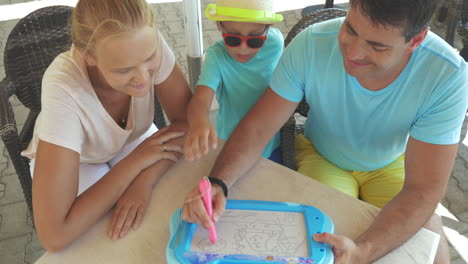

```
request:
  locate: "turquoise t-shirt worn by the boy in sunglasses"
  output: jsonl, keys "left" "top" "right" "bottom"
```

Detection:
{"left": 197, "top": 27, "right": 284, "bottom": 158}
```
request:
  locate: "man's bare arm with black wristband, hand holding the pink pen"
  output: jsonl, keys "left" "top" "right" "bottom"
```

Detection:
{"left": 182, "top": 88, "right": 298, "bottom": 228}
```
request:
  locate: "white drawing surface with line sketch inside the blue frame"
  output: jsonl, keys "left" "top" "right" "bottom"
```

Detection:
{"left": 190, "top": 210, "right": 308, "bottom": 257}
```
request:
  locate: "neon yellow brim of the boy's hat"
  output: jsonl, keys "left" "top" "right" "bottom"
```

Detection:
{"left": 205, "top": 4, "right": 283, "bottom": 24}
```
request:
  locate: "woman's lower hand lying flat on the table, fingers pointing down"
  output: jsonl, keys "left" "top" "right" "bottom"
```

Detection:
{"left": 109, "top": 178, "right": 153, "bottom": 240}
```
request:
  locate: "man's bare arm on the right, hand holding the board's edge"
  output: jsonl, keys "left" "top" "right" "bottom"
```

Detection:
{"left": 316, "top": 138, "right": 458, "bottom": 263}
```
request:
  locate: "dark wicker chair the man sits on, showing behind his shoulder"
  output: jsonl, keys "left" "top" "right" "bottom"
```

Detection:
{"left": 280, "top": 8, "right": 347, "bottom": 170}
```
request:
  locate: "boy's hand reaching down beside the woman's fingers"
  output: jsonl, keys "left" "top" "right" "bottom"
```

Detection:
{"left": 184, "top": 120, "right": 218, "bottom": 160}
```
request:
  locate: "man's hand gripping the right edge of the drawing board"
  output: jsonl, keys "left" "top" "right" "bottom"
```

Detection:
{"left": 314, "top": 233, "right": 367, "bottom": 264}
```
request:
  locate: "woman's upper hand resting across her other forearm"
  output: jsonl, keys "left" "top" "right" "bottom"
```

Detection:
{"left": 127, "top": 127, "right": 184, "bottom": 170}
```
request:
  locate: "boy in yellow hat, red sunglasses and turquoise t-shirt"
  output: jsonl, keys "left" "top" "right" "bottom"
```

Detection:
{"left": 185, "top": 0, "right": 284, "bottom": 163}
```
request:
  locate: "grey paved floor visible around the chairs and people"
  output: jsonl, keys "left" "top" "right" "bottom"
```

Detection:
{"left": 0, "top": 0, "right": 468, "bottom": 264}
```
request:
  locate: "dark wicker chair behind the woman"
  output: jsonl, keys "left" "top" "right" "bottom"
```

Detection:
{"left": 0, "top": 6, "right": 166, "bottom": 219}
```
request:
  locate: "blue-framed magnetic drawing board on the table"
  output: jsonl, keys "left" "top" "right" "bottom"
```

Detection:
{"left": 168, "top": 200, "right": 334, "bottom": 264}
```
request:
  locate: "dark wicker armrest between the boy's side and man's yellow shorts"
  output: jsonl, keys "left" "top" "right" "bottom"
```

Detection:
{"left": 280, "top": 115, "right": 296, "bottom": 170}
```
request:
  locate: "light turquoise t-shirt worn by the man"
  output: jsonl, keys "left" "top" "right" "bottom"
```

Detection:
{"left": 270, "top": 18, "right": 468, "bottom": 171}
